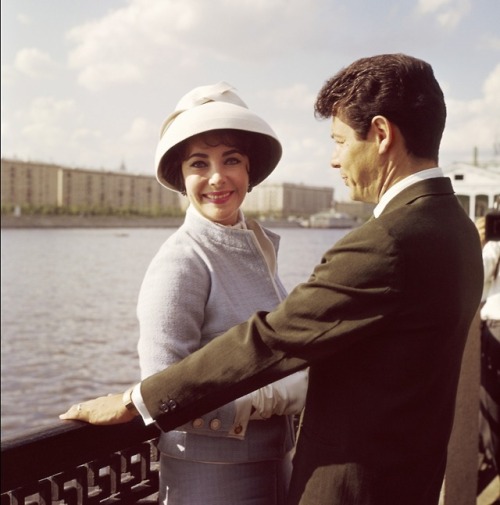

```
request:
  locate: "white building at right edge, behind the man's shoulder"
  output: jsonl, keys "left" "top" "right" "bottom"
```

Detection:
{"left": 443, "top": 163, "right": 500, "bottom": 219}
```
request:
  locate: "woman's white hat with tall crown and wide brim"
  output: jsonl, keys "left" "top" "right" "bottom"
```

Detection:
{"left": 155, "top": 81, "right": 282, "bottom": 192}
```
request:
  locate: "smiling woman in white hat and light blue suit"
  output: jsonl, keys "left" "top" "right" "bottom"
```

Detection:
{"left": 138, "top": 82, "right": 307, "bottom": 505}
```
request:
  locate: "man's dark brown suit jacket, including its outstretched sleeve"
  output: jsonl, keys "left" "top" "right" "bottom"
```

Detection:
{"left": 141, "top": 178, "right": 483, "bottom": 505}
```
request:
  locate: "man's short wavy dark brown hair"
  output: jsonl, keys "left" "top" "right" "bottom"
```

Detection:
{"left": 314, "top": 54, "right": 446, "bottom": 162}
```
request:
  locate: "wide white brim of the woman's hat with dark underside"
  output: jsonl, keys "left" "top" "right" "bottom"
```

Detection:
{"left": 155, "top": 102, "right": 282, "bottom": 192}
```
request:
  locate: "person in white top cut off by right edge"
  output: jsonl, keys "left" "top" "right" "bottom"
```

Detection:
{"left": 476, "top": 208, "right": 500, "bottom": 496}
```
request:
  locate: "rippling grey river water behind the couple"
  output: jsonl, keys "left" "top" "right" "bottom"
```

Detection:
{"left": 1, "top": 228, "right": 348, "bottom": 439}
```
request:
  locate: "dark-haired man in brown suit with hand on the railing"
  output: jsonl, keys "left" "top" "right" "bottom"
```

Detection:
{"left": 62, "top": 54, "right": 483, "bottom": 505}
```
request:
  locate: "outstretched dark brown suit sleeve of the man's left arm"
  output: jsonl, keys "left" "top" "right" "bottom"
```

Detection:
{"left": 141, "top": 221, "right": 404, "bottom": 430}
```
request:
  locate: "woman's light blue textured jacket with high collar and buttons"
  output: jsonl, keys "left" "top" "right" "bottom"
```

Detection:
{"left": 137, "top": 207, "right": 294, "bottom": 462}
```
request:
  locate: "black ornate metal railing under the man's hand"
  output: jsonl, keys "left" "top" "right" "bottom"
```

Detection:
{"left": 1, "top": 418, "right": 160, "bottom": 505}
